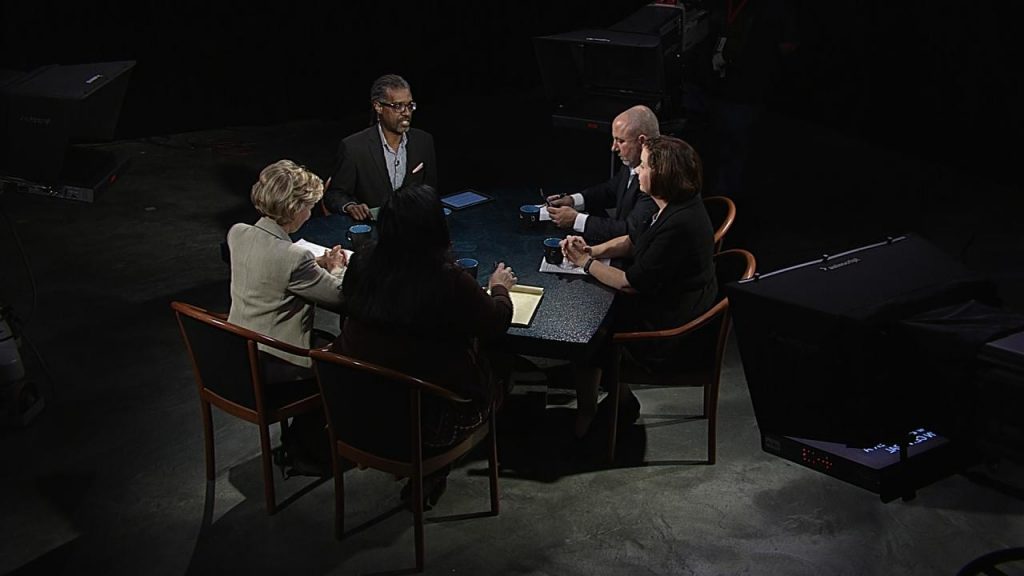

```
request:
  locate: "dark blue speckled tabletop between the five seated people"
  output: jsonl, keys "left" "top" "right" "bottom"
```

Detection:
{"left": 292, "top": 184, "right": 614, "bottom": 359}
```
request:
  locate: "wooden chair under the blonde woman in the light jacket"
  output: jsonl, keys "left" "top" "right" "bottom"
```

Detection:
{"left": 171, "top": 302, "right": 322, "bottom": 515}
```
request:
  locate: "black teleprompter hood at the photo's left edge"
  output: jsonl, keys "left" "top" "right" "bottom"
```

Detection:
{"left": 0, "top": 60, "right": 135, "bottom": 202}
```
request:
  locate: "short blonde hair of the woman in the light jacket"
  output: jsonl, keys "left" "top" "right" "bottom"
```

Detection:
{"left": 250, "top": 160, "right": 324, "bottom": 224}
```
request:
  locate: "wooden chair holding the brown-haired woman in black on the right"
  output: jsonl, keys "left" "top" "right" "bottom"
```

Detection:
{"left": 608, "top": 248, "right": 757, "bottom": 464}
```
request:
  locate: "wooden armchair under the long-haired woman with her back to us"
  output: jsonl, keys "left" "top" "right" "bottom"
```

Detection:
{"left": 310, "top": 349, "right": 499, "bottom": 572}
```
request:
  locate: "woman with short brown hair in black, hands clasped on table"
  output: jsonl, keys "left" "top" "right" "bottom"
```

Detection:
{"left": 562, "top": 136, "right": 718, "bottom": 438}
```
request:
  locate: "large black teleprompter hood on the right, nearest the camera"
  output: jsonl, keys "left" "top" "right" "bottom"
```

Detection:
{"left": 726, "top": 236, "right": 996, "bottom": 446}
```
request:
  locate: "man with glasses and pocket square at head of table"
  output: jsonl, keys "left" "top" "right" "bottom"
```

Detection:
{"left": 324, "top": 74, "right": 437, "bottom": 220}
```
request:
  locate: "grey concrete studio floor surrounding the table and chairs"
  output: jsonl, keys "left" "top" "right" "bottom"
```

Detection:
{"left": 0, "top": 114, "right": 1024, "bottom": 575}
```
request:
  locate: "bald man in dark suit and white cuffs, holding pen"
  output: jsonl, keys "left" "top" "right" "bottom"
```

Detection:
{"left": 541, "top": 106, "right": 659, "bottom": 245}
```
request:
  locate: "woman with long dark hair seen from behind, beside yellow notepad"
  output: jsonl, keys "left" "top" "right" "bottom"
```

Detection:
{"left": 334, "top": 184, "right": 516, "bottom": 503}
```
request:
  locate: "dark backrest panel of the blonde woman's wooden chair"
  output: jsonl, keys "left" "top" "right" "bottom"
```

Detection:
{"left": 176, "top": 306, "right": 256, "bottom": 410}
